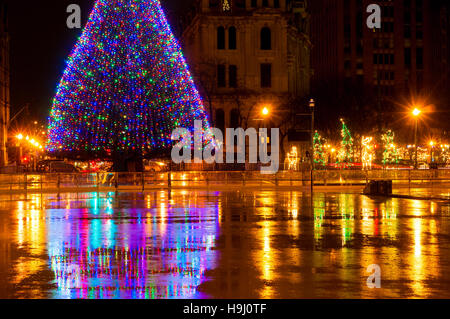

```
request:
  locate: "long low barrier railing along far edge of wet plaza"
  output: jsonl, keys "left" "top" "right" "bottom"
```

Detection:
{"left": 0, "top": 170, "right": 450, "bottom": 193}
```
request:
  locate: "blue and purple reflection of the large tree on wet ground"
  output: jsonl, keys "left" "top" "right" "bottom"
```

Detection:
{"left": 47, "top": 191, "right": 219, "bottom": 298}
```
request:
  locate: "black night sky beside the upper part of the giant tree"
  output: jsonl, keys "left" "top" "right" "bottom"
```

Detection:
{"left": 4, "top": 0, "right": 187, "bottom": 121}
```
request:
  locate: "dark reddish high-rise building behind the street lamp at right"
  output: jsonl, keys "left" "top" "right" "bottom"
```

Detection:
{"left": 310, "top": 0, "right": 449, "bottom": 129}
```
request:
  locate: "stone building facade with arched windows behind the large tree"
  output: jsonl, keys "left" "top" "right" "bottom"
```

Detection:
{"left": 181, "top": 0, "right": 311, "bottom": 135}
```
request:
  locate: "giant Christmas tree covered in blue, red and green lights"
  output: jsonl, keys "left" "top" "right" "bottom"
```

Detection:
{"left": 47, "top": 0, "right": 213, "bottom": 168}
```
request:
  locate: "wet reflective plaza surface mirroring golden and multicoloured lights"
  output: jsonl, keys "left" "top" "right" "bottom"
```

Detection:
{"left": 0, "top": 190, "right": 450, "bottom": 299}
